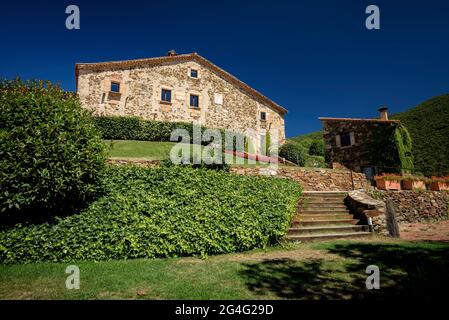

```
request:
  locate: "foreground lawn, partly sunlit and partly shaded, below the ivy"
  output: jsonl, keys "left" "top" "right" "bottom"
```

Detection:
{"left": 0, "top": 238, "right": 449, "bottom": 299}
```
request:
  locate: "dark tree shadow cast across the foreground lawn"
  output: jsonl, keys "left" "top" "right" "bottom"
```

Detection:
{"left": 241, "top": 243, "right": 449, "bottom": 300}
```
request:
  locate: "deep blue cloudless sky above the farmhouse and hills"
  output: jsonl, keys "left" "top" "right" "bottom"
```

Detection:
{"left": 0, "top": 0, "right": 449, "bottom": 136}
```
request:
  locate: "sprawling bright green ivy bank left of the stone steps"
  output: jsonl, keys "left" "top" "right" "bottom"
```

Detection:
{"left": 0, "top": 166, "right": 301, "bottom": 263}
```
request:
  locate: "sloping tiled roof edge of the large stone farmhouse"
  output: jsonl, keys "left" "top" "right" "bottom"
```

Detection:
{"left": 75, "top": 52, "right": 287, "bottom": 114}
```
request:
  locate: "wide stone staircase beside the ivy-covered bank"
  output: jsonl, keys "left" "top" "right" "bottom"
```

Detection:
{"left": 287, "top": 191, "right": 371, "bottom": 241}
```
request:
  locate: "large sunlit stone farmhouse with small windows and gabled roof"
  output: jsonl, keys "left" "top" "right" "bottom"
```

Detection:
{"left": 75, "top": 50, "right": 287, "bottom": 151}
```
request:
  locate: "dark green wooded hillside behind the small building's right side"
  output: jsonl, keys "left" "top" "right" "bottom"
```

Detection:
{"left": 392, "top": 94, "right": 449, "bottom": 176}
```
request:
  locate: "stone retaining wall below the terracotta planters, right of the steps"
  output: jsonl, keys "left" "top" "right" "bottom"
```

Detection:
{"left": 371, "top": 190, "right": 449, "bottom": 223}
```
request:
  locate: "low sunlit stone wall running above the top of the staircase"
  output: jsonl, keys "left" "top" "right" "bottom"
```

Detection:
{"left": 231, "top": 167, "right": 369, "bottom": 191}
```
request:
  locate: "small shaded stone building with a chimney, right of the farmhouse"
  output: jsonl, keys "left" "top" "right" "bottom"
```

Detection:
{"left": 319, "top": 108, "right": 400, "bottom": 178}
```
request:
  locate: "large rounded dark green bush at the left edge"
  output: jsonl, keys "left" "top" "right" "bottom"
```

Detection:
{"left": 0, "top": 80, "right": 105, "bottom": 216}
